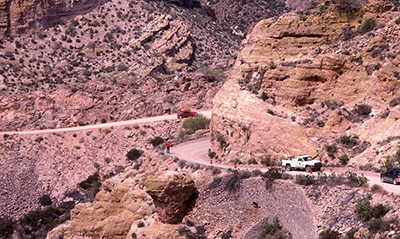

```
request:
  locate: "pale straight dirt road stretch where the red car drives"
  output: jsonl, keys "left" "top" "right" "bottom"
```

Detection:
{"left": 0, "top": 110, "right": 211, "bottom": 135}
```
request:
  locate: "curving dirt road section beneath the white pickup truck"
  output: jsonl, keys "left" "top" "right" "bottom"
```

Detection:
{"left": 171, "top": 138, "right": 400, "bottom": 194}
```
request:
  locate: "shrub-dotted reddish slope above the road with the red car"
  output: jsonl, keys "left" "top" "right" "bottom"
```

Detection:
{"left": 0, "top": 0, "right": 294, "bottom": 130}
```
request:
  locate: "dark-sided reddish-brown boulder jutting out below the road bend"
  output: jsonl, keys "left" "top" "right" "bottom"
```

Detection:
{"left": 145, "top": 171, "right": 196, "bottom": 223}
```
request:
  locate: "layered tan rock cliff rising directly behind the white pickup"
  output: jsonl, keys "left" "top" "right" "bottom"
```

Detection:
{"left": 212, "top": 1, "right": 400, "bottom": 167}
